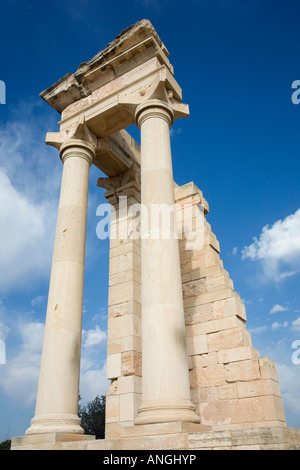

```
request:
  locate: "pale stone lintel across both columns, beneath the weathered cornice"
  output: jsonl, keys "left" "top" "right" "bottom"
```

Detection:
{"left": 59, "top": 60, "right": 184, "bottom": 137}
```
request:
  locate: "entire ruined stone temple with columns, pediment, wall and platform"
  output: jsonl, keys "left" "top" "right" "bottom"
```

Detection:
{"left": 12, "top": 20, "right": 300, "bottom": 450}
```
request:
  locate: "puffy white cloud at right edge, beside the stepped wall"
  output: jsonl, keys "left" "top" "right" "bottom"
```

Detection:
{"left": 242, "top": 209, "right": 300, "bottom": 281}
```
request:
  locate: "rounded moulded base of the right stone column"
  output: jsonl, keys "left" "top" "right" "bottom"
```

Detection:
{"left": 134, "top": 400, "right": 200, "bottom": 425}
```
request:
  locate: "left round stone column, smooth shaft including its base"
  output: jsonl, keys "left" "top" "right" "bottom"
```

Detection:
{"left": 26, "top": 139, "right": 94, "bottom": 434}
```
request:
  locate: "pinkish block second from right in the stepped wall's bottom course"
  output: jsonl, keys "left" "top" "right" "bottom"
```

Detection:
{"left": 232, "top": 397, "right": 265, "bottom": 423}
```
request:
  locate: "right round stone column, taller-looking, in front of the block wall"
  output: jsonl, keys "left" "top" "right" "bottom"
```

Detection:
{"left": 135, "top": 99, "right": 200, "bottom": 424}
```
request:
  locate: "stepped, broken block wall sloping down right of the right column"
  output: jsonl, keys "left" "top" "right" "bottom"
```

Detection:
{"left": 175, "top": 183, "right": 285, "bottom": 429}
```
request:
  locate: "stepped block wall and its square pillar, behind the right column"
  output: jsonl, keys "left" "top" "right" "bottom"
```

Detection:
{"left": 106, "top": 179, "right": 285, "bottom": 437}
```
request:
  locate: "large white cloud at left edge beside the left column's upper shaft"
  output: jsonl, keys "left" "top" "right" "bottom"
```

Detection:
{"left": 0, "top": 169, "right": 55, "bottom": 291}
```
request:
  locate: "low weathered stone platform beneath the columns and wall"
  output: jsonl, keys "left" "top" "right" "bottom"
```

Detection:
{"left": 12, "top": 423, "right": 300, "bottom": 451}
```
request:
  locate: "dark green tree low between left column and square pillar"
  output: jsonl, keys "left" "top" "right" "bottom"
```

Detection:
{"left": 78, "top": 395, "right": 105, "bottom": 439}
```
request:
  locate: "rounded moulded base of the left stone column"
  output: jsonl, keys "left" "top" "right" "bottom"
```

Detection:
{"left": 25, "top": 413, "right": 84, "bottom": 435}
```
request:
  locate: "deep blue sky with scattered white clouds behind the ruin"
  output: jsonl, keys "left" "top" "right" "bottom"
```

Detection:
{"left": 0, "top": 0, "right": 300, "bottom": 442}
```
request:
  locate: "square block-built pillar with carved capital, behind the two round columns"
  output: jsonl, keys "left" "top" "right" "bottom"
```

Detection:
{"left": 106, "top": 184, "right": 142, "bottom": 438}
